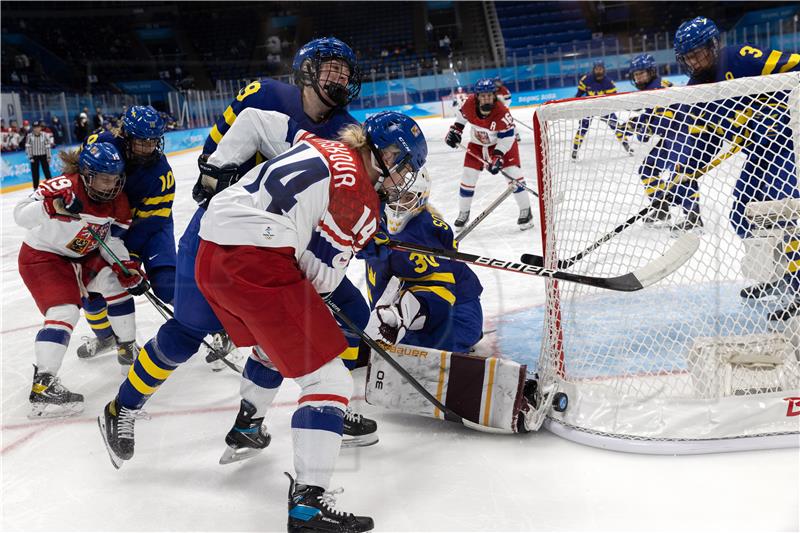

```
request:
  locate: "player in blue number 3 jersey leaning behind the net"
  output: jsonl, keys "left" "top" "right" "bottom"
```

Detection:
{"left": 675, "top": 17, "right": 800, "bottom": 320}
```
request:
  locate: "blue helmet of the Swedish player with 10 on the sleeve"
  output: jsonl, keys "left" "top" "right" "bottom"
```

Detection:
{"left": 122, "top": 105, "right": 167, "bottom": 165}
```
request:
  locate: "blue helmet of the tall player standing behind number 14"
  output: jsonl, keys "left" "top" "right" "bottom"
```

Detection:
{"left": 292, "top": 37, "right": 361, "bottom": 107}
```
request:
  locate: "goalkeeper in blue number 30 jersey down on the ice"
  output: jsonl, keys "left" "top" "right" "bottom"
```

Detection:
{"left": 357, "top": 169, "right": 539, "bottom": 432}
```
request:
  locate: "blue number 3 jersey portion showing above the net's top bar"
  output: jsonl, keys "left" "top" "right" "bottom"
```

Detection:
{"left": 688, "top": 44, "right": 800, "bottom": 85}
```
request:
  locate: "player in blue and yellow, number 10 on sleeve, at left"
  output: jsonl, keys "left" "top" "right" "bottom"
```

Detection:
{"left": 78, "top": 106, "right": 176, "bottom": 359}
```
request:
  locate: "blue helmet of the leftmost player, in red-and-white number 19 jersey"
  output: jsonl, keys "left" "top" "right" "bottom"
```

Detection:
{"left": 78, "top": 143, "right": 125, "bottom": 202}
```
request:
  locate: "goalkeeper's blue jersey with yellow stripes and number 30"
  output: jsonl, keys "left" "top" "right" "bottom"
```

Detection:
{"left": 367, "top": 210, "right": 483, "bottom": 329}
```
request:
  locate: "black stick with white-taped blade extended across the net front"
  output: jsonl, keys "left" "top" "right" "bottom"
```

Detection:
{"left": 386, "top": 233, "right": 700, "bottom": 292}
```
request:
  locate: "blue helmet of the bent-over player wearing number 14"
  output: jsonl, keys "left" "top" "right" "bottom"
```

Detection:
{"left": 364, "top": 111, "right": 428, "bottom": 201}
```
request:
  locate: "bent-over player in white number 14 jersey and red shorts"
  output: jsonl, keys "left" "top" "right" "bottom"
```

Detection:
{"left": 196, "top": 112, "right": 427, "bottom": 532}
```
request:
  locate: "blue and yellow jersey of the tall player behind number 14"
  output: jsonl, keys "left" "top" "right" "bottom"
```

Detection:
{"left": 203, "top": 79, "right": 358, "bottom": 174}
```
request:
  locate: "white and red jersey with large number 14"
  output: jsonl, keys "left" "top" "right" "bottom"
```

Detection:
{"left": 200, "top": 138, "right": 380, "bottom": 293}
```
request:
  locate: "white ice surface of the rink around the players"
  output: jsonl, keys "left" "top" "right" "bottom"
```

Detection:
{"left": 0, "top": 113, "right": 800, "bottom": 531}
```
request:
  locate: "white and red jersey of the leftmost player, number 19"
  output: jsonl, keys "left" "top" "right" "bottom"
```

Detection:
{"left": 14, "top": 174, "right": 131, "bottom": 264}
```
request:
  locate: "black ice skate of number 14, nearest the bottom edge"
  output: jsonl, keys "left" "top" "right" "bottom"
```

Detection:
{"left": 284, "top": 472, "right": 375, "bottom": 533}
